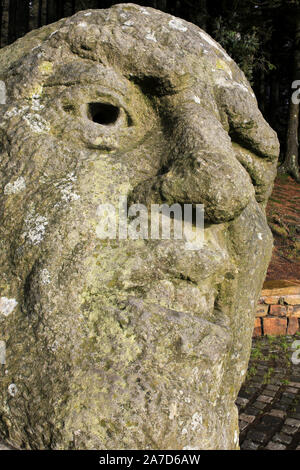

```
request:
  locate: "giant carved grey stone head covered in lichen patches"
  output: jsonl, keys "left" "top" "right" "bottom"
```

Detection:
{"left": 0, "top": 4, "right": 278, "bottom": 449}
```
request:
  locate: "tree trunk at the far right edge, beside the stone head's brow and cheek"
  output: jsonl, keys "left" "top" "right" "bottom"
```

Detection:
{"left": 279, "top": 12, "right": 300, "bottom": 182}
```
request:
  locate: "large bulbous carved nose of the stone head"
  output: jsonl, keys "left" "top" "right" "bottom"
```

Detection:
{"left": 129, "top": 106, "right": 254, "bottom": 223}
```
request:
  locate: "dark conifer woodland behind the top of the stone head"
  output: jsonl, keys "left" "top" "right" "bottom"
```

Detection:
{"left": 0, "top": 0, "right": 300, "bottom": 181}
